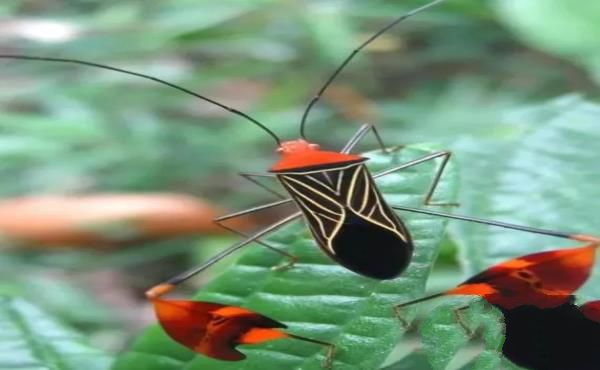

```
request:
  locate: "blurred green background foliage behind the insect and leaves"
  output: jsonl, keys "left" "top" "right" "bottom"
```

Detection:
{"left": 0, "top": 0, "right": 600, "bottom": 368}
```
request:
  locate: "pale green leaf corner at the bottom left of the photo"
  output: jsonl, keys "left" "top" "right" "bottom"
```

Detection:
{"left": 0, "top": 297, "right": 112, "bottom": 370}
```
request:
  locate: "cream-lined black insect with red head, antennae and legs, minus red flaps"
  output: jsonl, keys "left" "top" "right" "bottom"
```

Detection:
{"left": 0, "top": 0, "right": 596, "bottom": 286}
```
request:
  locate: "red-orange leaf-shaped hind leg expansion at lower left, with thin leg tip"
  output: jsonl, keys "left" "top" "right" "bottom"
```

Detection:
{"left": 145, "top": 290, "right": 335, "bottom": 368}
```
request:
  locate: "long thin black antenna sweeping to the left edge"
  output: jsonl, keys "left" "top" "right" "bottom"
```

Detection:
{"left": 0, "top": 54, "right": 281, "bottom": 146}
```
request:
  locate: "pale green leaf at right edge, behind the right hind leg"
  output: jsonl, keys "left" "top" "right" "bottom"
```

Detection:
{"left": 450, "top": 96, "right": 600, "bottom": 369}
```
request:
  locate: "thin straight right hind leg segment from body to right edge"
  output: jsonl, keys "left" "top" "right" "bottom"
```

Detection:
{"left": 390, "top": 205, "right": 600, "bottom": 246}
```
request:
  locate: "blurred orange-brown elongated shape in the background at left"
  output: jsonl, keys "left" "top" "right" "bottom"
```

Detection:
{"left": 0, "top": 193, "right": 250, "bottom": 247}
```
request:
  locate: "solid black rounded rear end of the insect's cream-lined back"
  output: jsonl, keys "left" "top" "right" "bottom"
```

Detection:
{"left": 332, "top": 212, "right": 413, "bottom": 280}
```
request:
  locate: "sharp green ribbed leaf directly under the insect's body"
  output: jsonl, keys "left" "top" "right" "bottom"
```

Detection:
{"left": 114, "top": 146, "right": 456, "bottom": 370}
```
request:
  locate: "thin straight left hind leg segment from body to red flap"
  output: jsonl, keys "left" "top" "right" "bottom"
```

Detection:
{"left": 146, "top": 212, "right": 301, "bottom": 299}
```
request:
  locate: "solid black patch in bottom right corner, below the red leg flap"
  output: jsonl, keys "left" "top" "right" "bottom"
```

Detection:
{"left": 502, "top": 303, "right": 600, "bottom": 370}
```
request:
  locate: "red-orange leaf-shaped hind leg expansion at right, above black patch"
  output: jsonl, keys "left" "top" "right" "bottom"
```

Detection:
{"left": 446, "top": 243, "right": 598, "bottom": 309}
